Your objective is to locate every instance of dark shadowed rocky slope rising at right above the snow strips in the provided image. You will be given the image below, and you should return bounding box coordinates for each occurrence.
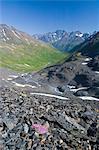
[31,32,99,98]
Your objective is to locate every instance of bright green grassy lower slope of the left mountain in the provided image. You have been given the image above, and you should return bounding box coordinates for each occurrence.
[0,45,68,72]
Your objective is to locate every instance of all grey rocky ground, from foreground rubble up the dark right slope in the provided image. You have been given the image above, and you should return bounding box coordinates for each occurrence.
[0,29,99,150]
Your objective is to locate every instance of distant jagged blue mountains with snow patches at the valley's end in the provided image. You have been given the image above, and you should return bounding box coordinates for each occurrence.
[33,30,89,51]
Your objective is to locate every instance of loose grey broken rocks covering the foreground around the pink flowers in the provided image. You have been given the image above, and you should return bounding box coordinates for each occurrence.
[0,87,99,150]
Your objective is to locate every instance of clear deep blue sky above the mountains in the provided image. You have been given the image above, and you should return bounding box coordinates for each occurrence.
[0,0,99,34]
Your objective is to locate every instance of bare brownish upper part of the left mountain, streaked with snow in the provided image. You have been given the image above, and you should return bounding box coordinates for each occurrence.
[0,24,37,44]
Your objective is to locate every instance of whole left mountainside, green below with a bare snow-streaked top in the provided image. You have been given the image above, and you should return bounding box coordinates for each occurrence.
[0,24,66,72]
